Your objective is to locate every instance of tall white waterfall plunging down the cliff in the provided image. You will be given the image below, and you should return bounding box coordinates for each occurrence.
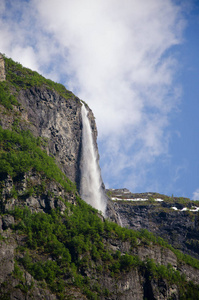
[80,104,106,215]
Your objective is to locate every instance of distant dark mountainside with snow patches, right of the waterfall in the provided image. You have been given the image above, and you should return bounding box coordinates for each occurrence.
[107,189,199,259]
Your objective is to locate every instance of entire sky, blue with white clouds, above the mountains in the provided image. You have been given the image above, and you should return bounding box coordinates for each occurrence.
[0,0,199,200]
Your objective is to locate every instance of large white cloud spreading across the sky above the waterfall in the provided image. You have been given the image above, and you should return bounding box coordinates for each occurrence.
[0,0,187,191]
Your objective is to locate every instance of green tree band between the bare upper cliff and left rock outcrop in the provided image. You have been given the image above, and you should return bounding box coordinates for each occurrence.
[0,126,75,191]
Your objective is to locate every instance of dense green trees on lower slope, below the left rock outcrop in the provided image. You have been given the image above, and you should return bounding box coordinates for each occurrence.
[11,204,109,299]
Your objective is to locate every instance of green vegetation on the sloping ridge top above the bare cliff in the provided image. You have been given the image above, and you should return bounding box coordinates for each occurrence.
[4,55,74,99]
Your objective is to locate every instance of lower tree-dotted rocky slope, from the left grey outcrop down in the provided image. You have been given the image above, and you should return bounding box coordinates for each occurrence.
[0,171,199,300]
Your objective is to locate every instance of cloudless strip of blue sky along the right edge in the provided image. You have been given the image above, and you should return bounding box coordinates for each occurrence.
[170,1,199,199]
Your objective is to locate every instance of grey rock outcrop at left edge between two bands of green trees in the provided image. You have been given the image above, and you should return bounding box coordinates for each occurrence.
[0,171,75,213]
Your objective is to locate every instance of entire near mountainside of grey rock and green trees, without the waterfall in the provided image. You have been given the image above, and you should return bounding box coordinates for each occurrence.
[0,57,199,300]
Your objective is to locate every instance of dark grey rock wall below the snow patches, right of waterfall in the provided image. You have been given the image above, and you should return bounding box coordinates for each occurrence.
[107,189,199,259]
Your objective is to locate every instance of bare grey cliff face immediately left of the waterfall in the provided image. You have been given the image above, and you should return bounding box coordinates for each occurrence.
[18,86,81,186]
